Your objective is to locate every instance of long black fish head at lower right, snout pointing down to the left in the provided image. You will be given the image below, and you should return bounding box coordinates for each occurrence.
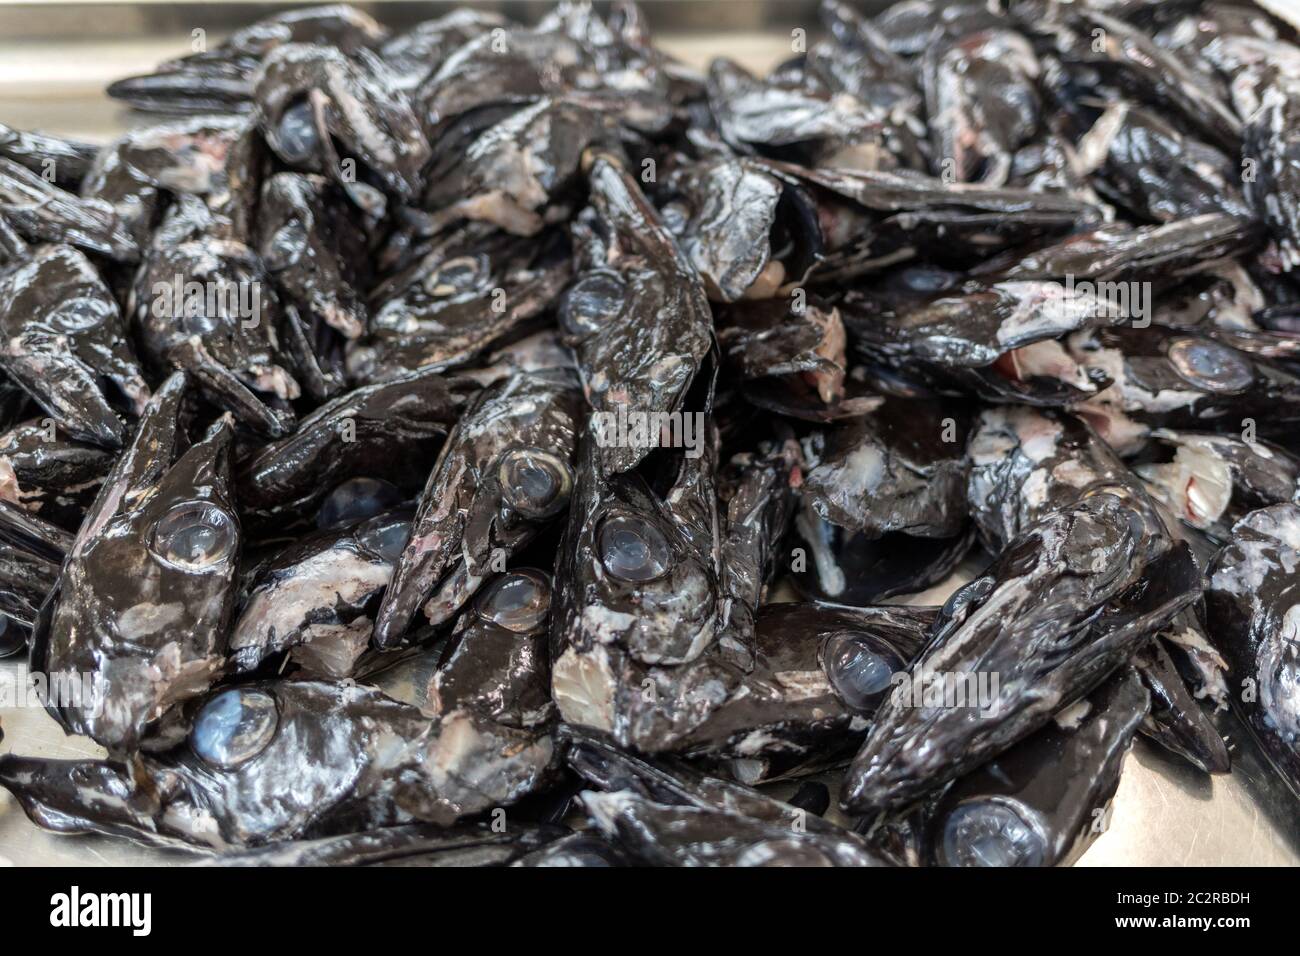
[841,493,1200,812]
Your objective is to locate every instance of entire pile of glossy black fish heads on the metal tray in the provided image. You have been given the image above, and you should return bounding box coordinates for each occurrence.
[0,0,1300,865]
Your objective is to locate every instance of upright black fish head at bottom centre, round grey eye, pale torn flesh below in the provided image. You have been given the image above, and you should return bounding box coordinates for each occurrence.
[551,434,733,752]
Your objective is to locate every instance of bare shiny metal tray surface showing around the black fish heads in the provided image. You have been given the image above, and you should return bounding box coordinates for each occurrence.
[0,0,1300,866]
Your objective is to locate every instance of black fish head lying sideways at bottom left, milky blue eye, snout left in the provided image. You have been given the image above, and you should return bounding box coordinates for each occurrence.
[0,682,554,851]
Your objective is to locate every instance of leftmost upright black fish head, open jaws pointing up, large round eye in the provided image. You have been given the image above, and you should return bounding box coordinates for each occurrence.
[31,373,239,754]
